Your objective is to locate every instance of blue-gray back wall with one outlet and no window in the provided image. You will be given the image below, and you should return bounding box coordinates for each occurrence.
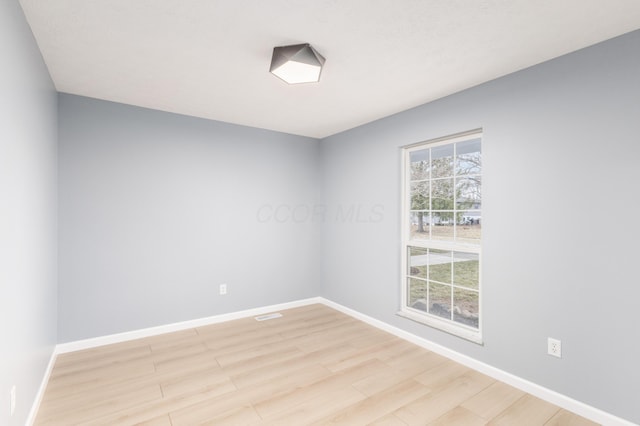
[58,94,320,343]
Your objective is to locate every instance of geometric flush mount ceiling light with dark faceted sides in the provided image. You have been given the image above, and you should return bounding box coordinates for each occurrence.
[269,43,324,84]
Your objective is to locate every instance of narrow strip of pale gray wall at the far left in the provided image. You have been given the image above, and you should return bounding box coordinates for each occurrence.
[0,1,57,425]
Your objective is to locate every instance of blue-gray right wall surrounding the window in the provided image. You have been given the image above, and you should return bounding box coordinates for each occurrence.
[321,31,640,423]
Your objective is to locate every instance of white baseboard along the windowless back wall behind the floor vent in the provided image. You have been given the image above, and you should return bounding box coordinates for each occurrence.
[55,297,322,354]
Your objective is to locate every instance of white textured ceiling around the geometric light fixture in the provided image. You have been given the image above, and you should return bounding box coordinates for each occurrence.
[21,0,640,138]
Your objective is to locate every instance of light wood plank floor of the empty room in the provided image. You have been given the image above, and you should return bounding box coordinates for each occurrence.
[35,305,594,426]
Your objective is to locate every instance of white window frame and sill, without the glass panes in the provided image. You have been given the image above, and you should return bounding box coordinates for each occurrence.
[398,129,483,344]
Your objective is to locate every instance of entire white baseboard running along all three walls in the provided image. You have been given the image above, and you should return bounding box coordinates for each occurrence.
[41,297,637,426]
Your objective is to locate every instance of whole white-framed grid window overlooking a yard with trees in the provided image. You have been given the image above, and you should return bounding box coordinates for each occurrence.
[399,131,482,343]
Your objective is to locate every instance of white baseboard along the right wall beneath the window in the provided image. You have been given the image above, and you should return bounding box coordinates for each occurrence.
[320,298,637,426]
